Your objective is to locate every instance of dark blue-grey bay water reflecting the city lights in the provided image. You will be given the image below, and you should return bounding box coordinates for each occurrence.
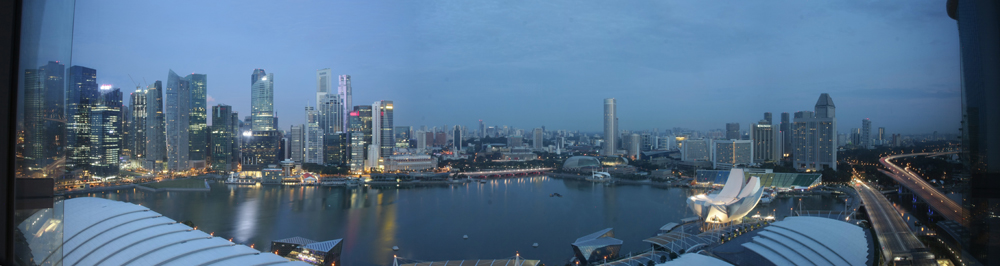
[66,177,843,265]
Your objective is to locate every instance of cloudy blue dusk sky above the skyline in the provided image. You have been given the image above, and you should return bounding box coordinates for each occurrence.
[72,0,961,134]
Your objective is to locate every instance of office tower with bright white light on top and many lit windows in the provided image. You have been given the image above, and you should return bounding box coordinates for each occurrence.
[90,85,122,178]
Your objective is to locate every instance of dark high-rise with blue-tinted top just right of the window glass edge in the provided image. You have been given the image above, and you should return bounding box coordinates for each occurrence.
[66,66,100,169]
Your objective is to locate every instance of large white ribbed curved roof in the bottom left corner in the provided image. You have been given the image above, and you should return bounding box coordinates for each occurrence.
[30,198,309,266]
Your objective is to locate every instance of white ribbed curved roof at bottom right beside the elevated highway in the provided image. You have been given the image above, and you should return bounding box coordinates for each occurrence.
[743,216,868,265]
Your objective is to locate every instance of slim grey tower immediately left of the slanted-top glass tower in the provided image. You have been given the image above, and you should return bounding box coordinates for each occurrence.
[143,80,167,172]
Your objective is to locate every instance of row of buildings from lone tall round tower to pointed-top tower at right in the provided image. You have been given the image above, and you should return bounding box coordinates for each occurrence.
[601,93,840,171]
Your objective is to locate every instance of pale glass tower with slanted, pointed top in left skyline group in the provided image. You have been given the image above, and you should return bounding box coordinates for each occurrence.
[164,70,191,171]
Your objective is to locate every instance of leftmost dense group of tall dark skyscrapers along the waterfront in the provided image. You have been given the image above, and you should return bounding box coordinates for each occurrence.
[22,62,217,178]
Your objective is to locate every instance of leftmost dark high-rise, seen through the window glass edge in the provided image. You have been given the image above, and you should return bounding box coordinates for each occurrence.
[24,61,65,177]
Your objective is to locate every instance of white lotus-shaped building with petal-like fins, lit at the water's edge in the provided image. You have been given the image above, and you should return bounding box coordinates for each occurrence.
[687,169,764,223]
